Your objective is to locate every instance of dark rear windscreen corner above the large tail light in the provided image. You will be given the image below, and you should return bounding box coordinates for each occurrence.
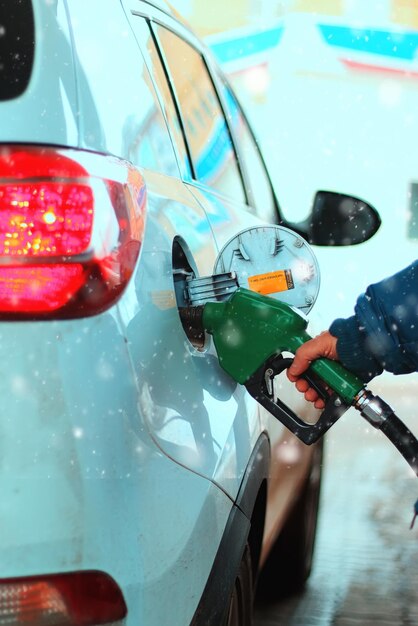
[0,0,35,100]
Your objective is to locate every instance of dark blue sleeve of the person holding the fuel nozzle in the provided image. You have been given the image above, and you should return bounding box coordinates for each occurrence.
[330,261,418,381]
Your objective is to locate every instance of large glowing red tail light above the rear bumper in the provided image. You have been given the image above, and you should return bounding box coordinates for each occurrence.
[0,146,145,319]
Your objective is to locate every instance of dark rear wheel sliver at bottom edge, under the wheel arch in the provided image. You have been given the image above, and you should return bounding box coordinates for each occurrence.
[224,544,254,626]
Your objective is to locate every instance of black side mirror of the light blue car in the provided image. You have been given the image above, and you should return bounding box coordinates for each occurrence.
[305,191,381,246]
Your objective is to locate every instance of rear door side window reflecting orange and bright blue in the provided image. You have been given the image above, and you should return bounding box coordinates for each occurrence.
[156,26,246,202]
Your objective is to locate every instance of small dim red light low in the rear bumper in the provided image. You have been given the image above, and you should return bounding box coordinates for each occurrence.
[0,572,127,626]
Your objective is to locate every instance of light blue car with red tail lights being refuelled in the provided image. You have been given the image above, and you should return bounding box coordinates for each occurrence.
[0,0,378,626]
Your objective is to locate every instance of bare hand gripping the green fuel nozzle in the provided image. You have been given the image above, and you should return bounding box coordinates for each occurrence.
[287,330,338,409]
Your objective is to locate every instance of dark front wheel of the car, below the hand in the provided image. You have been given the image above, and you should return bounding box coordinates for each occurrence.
[258,441,323,601]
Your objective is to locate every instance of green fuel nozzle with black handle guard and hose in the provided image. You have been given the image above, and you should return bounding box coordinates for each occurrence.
[181,288,418,482]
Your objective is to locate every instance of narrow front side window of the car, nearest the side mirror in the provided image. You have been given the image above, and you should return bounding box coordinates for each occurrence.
[221,78,278,223]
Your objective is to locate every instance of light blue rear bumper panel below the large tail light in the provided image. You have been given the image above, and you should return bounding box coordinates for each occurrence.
[0,310,232,626]
